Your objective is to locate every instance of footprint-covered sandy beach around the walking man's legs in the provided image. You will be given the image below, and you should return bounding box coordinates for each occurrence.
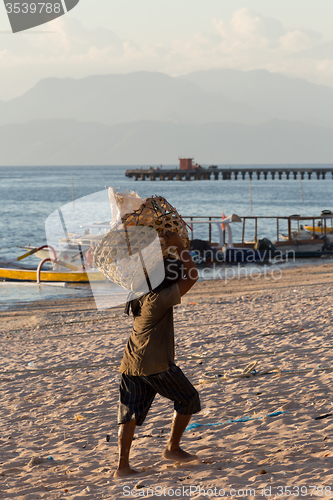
[0,261,333,500]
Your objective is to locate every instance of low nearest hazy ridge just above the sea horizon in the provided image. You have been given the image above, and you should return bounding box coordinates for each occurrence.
[0,120,333,165]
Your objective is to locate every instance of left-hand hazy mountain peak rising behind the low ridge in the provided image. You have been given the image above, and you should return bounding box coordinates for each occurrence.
[0,72,272,125]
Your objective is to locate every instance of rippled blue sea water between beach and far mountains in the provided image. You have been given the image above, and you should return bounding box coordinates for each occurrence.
[0,165,333,307]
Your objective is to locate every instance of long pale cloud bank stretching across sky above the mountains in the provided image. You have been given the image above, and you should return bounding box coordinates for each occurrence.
[0,8,333,98]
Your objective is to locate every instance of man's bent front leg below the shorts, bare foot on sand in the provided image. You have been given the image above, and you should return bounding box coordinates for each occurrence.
[163,411,198,462]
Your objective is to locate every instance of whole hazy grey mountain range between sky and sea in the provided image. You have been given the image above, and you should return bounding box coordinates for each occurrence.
[0,69,333,166]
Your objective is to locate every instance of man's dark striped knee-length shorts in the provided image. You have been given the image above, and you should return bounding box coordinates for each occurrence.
[118,364,201,425]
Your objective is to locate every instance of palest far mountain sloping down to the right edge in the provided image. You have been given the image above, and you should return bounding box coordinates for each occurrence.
[180,69,333,126]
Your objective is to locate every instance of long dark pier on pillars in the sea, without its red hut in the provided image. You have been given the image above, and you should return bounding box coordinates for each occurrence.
[125,165,333,181]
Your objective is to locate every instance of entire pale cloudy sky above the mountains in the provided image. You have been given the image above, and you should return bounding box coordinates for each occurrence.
[0,0,333,100]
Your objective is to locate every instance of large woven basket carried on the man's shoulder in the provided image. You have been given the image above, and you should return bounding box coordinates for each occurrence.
[94,196,190,291]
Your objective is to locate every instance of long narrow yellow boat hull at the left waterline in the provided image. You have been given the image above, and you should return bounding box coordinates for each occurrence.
[0,268,105,283]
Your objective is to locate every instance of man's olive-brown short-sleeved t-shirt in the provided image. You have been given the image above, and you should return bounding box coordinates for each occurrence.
[119,284,181,376]
